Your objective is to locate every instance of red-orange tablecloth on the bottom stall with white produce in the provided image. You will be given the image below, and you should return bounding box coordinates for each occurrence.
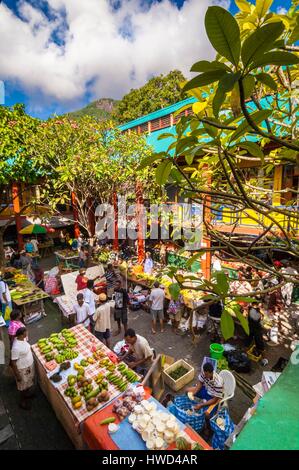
[83,391,211,450]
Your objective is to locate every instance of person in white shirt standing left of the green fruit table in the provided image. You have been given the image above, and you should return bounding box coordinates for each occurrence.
[11,327,35,410]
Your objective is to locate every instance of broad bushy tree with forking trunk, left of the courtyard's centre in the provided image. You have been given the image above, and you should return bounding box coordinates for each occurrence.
[31,116,163,237]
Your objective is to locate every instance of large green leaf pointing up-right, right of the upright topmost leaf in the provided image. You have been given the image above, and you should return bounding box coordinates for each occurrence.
[241,22,284,68]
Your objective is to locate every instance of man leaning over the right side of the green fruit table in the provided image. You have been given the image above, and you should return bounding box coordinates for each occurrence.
[121,328,153,375]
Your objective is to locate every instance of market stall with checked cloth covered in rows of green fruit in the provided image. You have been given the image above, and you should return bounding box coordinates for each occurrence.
[32,325,139,449]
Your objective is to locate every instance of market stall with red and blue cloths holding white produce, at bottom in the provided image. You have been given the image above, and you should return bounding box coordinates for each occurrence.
[83,387,211,450]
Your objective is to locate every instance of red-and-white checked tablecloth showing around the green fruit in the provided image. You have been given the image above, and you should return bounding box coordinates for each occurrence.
[32,325,132,449]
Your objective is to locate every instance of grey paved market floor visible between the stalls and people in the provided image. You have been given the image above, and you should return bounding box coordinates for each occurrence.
[0,300,287,450]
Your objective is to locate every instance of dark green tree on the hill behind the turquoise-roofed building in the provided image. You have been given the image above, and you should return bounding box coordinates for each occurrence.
[112,70,185,124]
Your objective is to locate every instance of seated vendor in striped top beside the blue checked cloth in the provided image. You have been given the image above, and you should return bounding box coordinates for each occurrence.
[187,362,223,417]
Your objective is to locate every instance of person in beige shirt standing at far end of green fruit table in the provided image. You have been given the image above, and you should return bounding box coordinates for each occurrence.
[93,293,114,348]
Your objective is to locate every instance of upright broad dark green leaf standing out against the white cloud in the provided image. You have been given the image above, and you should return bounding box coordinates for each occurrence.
[205,6,241,65]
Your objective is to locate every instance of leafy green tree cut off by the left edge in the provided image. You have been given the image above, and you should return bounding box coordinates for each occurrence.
[0,104,39,265]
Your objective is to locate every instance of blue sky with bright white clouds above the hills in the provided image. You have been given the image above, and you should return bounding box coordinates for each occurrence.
[0,0,290,119]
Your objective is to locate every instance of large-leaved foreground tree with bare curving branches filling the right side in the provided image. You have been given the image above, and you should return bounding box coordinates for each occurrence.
[142,0,299,339]
